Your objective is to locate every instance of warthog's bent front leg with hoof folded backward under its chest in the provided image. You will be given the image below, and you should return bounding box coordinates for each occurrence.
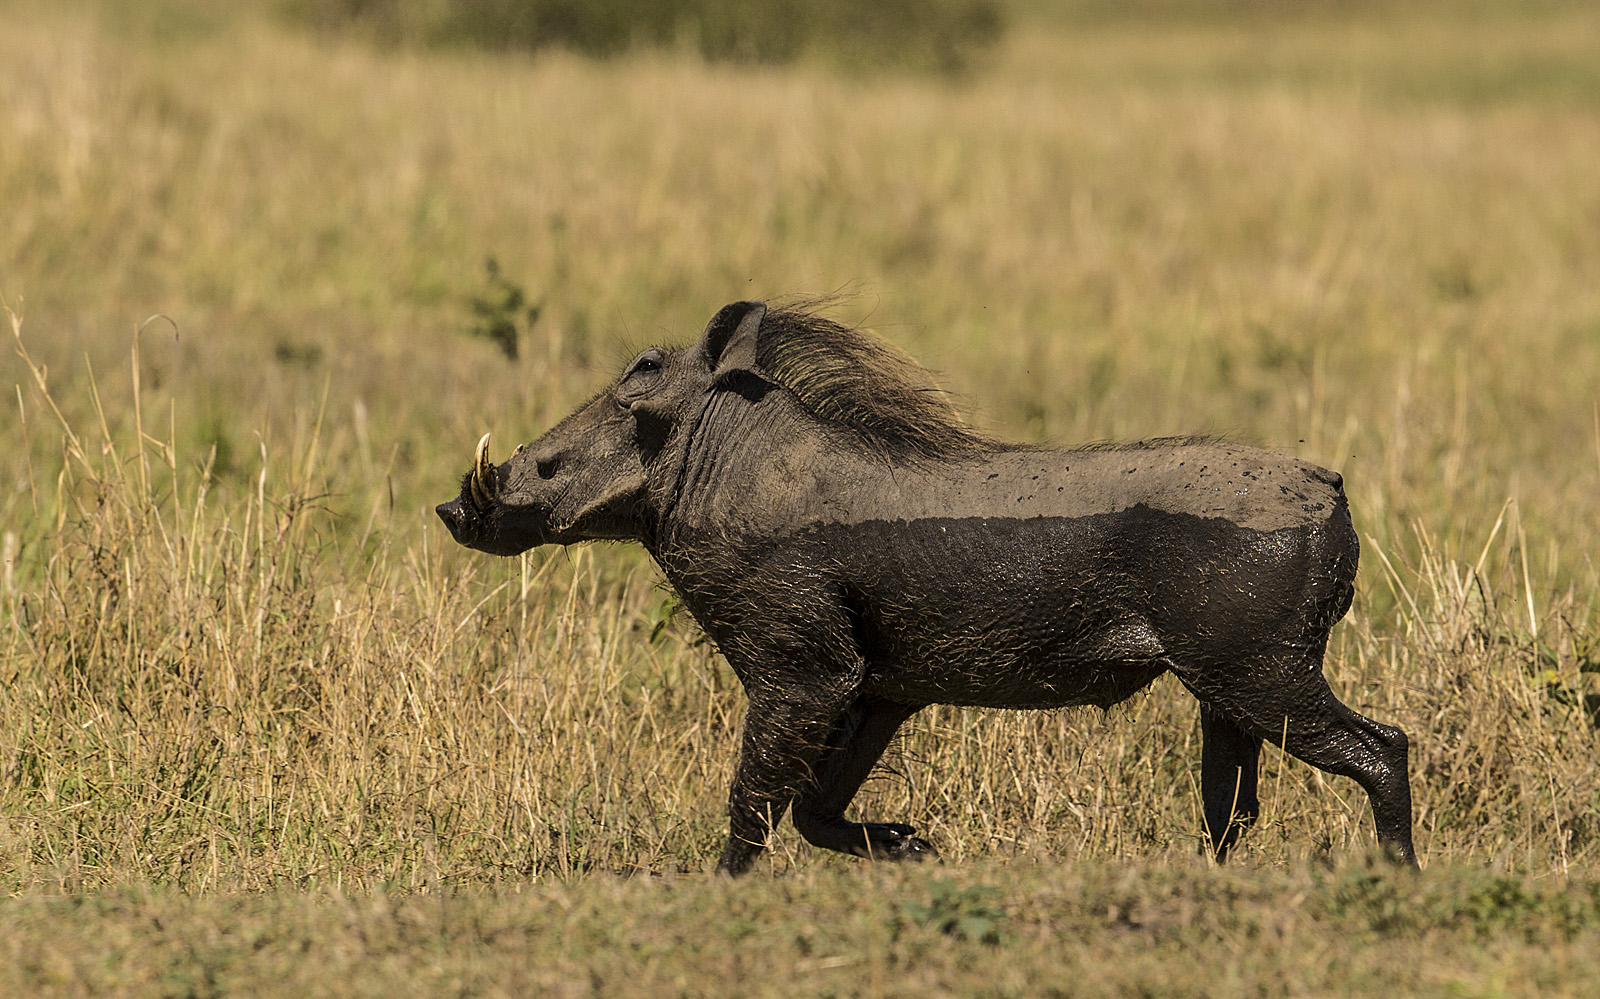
[794,696,934,860]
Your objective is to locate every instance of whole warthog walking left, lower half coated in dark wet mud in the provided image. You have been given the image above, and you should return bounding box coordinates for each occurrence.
[438,303,1416,874]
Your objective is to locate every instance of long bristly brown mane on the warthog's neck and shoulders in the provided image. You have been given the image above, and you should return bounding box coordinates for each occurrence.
[755,303,1018,461]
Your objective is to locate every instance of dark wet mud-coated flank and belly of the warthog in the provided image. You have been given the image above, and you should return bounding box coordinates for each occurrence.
[787,506,1349,708]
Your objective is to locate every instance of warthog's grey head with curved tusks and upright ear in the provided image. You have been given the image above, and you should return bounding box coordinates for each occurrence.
[437,303,766,556]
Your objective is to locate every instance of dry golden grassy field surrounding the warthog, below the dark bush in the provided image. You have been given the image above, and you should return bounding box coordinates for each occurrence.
[0,0,1600,996]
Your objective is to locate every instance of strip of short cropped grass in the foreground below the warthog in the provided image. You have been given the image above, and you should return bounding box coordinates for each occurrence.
[0,863,1600,997]
